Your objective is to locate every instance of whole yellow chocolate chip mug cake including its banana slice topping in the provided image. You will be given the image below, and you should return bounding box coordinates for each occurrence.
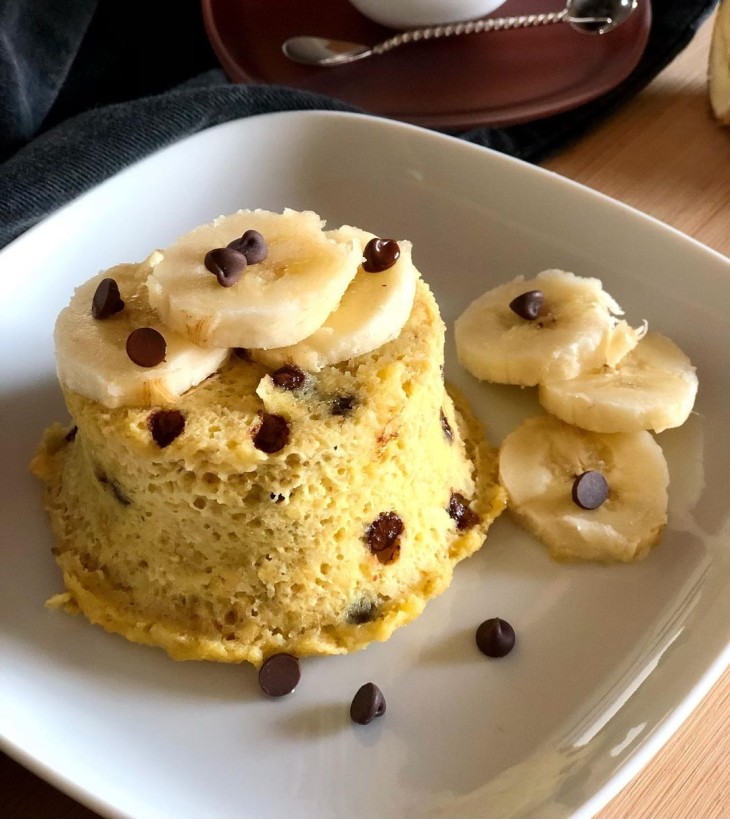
[32,210,505,665]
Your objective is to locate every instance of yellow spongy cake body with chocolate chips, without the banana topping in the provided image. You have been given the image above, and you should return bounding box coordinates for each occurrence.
[33,282,504,665]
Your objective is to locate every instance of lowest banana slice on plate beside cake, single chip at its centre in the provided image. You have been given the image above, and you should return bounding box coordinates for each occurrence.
[499,415,669,563]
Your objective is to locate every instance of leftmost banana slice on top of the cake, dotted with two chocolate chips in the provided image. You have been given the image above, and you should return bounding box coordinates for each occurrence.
[54,254,229,408]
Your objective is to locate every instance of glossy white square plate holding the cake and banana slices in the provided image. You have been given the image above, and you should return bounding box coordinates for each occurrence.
[0,112,730,819]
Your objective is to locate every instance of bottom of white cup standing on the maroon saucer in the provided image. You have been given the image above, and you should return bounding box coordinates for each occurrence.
[350,0,505,29]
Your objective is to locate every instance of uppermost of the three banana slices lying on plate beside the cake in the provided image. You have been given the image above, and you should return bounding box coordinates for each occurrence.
[454,270,644,387]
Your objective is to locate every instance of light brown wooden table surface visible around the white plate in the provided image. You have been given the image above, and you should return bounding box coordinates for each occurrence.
[0,8,730,819]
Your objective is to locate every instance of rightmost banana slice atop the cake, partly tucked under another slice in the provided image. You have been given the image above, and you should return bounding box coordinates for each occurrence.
[251,226,419,372]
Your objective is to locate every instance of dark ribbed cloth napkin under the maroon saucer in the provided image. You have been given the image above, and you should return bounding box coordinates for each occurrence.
[0,0,717,247]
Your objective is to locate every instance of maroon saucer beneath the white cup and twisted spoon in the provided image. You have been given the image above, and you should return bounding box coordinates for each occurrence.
[202,0,651,128]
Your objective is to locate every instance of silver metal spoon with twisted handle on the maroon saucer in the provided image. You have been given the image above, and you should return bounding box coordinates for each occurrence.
[281,0,638,67]
